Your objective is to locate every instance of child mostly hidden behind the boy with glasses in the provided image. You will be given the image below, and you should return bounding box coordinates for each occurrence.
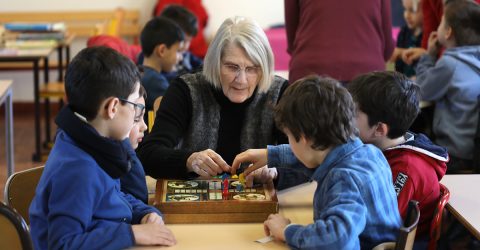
[120,85,148,204]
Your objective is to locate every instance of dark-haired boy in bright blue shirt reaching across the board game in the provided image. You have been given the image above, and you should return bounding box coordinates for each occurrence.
[232,76,401,249]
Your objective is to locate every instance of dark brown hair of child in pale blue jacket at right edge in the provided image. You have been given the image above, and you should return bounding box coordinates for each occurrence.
[444,0,480,46]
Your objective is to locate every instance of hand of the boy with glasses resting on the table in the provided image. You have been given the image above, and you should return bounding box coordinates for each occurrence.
[132,224,177,246]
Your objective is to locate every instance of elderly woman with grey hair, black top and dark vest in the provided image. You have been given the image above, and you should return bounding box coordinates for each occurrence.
[137,17,287,178]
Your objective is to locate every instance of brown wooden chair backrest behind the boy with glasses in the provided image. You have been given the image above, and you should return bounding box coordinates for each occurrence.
[4,166,44,224]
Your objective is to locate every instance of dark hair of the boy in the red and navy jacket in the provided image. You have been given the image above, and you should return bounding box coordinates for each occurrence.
[347,71,420,139]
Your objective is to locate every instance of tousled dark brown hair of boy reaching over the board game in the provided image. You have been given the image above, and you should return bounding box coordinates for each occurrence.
[275,75,357,150]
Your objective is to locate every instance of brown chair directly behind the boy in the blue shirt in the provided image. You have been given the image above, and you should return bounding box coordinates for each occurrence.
[373,200,420,250]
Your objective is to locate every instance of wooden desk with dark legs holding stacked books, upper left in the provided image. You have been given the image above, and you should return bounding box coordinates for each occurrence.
[0,47,55,161]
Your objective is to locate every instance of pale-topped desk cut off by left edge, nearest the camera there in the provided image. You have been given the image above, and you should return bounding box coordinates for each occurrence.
[0,80,15,178]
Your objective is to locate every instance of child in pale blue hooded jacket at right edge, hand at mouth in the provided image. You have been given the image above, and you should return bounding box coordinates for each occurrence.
[416,0,480,174]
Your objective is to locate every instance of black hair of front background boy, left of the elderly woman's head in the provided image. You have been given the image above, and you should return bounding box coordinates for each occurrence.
[140,17,184,56]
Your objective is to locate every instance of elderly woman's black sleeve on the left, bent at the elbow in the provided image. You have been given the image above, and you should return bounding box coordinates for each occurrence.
[137,79,193,178]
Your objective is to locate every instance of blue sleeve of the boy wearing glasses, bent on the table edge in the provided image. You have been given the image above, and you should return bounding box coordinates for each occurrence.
[47,162,135,249]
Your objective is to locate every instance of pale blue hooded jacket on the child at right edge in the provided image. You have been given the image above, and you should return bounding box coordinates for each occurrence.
[417,46,480,159]
